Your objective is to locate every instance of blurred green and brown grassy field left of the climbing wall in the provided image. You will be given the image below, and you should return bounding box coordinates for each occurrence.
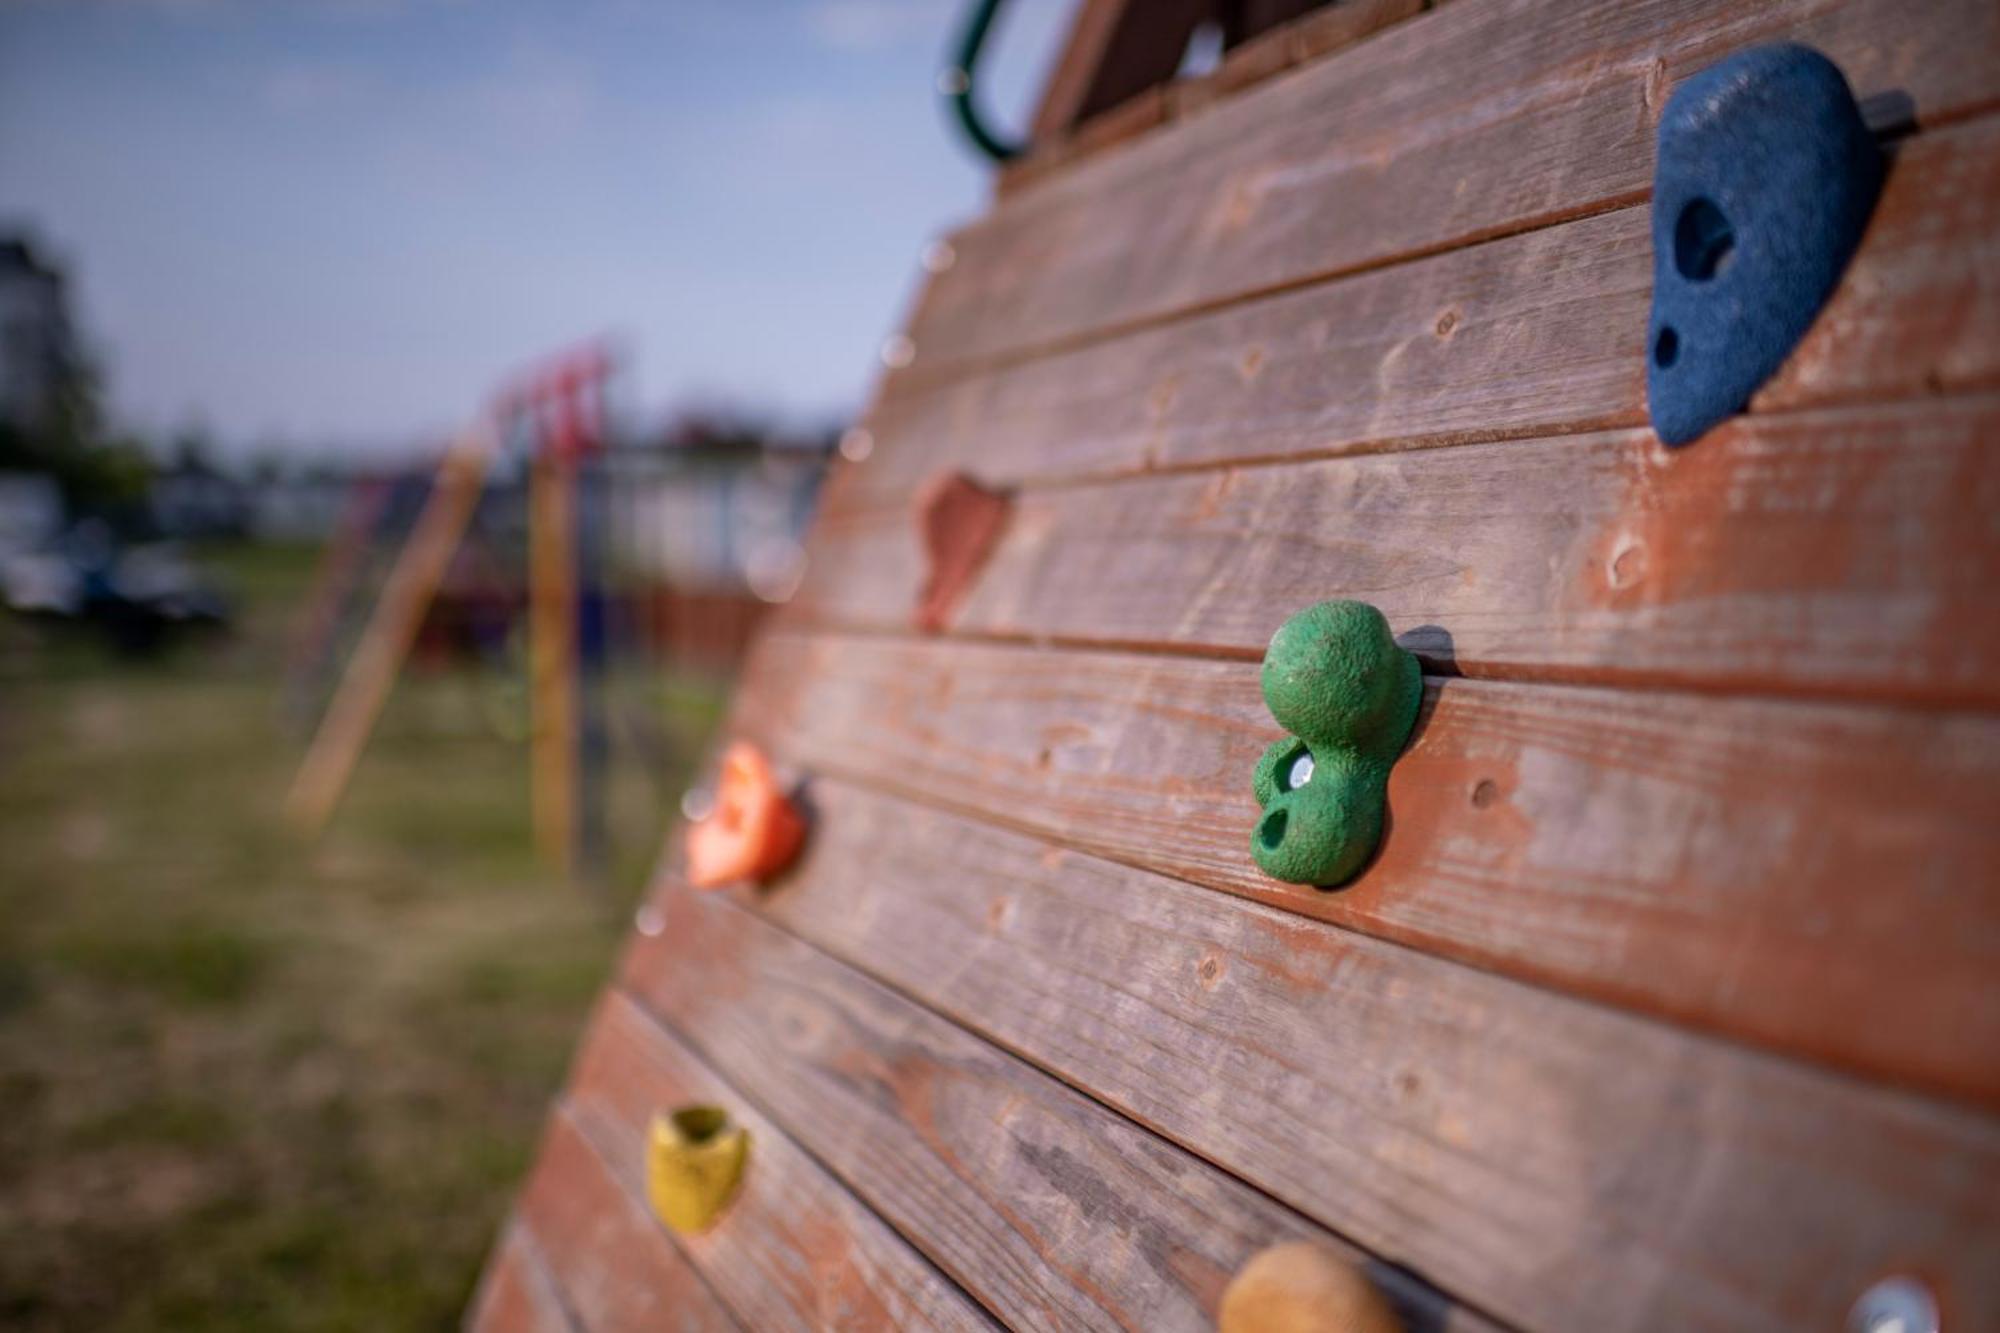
[0,550,716,1331]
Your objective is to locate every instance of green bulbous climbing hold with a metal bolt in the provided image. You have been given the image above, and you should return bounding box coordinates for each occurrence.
[1250,602,1424,889]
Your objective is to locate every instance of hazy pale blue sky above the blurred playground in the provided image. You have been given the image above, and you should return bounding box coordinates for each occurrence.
[0,0,1070,452]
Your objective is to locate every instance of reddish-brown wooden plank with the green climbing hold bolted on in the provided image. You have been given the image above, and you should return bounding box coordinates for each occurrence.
[736,634,2000,1107]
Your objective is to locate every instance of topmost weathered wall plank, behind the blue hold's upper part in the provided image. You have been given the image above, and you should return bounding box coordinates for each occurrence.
[898,0,2000,382]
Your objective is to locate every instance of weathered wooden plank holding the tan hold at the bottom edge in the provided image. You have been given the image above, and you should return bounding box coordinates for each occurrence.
[622,891,1486,1333]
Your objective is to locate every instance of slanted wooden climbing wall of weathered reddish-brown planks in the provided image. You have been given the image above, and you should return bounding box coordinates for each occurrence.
[470,0,2000,1333]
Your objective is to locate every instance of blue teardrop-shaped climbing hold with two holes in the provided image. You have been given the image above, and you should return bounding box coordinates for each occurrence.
[1646,42,1882,444]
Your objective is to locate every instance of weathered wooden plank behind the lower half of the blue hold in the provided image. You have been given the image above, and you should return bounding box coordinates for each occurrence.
[846,118,2000,504]
